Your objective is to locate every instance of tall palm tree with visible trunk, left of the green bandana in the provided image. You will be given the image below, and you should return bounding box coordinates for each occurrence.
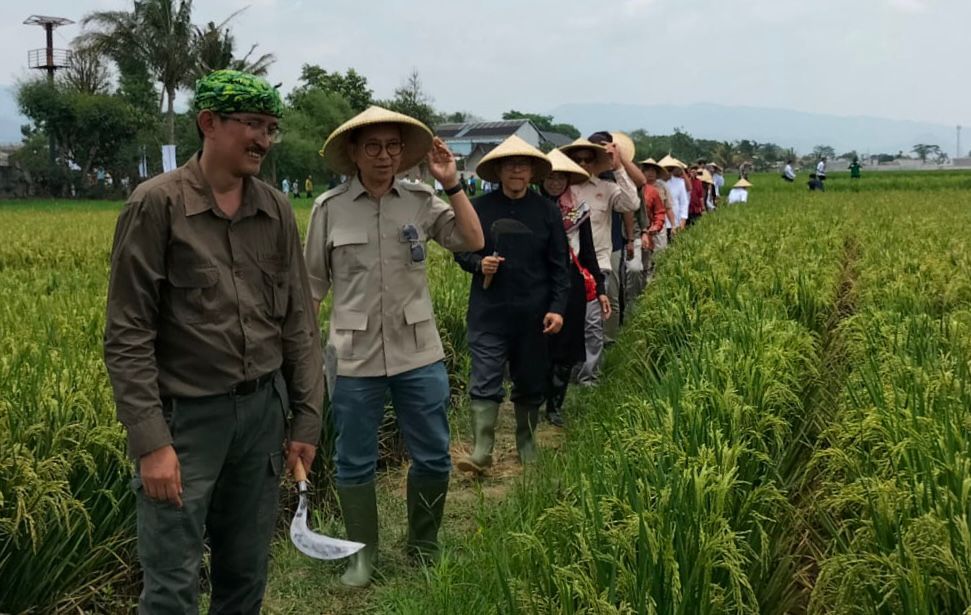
[79,0,197,143]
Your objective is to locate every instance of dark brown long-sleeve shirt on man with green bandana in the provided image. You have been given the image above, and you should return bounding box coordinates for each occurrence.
[105,156,324,459]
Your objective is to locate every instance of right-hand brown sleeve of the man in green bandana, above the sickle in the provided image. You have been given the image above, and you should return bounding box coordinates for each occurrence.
[282,212,325,444]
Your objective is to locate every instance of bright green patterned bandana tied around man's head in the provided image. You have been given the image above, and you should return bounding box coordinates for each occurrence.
[192,70,283,117]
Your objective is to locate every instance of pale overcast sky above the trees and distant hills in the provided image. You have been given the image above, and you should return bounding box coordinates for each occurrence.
[0,0,971,125]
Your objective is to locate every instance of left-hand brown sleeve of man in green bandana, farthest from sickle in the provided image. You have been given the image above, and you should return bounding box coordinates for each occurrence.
[104,197,172,459]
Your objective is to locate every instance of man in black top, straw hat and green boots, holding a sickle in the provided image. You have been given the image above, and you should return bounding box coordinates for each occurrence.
[455,135,570,474]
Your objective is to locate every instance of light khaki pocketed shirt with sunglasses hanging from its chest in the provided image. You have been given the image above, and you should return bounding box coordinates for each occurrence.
[305,176,469,377]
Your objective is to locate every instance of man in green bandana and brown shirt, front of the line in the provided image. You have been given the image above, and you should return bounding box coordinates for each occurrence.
[105,70,324,614]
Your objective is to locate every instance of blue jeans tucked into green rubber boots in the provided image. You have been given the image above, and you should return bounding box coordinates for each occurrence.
[331,361,452,487]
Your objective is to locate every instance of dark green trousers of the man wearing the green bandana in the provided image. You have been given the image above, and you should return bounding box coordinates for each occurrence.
[133,377,286,615]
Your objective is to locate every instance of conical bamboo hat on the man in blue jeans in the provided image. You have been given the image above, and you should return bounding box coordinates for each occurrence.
[320,105,433,175]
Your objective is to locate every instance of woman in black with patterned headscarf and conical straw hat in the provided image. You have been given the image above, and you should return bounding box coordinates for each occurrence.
[542,150,610,427]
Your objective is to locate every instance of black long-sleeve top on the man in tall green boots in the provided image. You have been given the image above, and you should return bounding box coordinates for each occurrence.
[455,189,570,330]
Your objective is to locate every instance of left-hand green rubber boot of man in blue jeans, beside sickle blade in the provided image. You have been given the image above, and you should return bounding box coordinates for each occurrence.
[337,481,378,587]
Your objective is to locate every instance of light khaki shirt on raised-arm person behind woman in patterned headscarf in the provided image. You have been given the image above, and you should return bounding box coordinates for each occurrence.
[570,168,641,272]
